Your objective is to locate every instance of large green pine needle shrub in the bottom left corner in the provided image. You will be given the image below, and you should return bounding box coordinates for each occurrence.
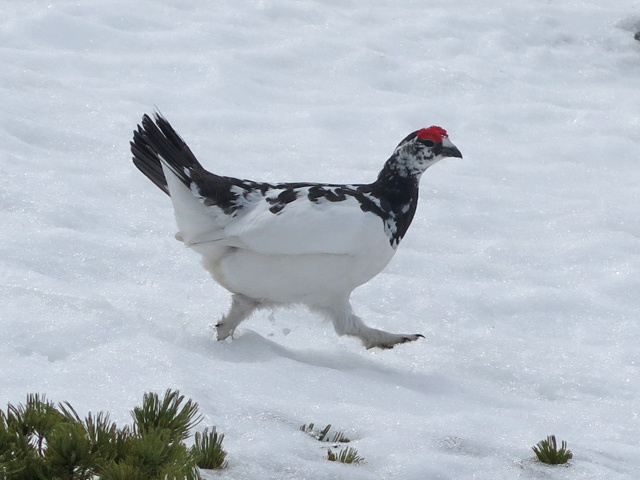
[0,390,226,480]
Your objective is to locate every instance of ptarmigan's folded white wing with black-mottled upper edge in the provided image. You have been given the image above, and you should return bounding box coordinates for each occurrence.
[161,159,392,255]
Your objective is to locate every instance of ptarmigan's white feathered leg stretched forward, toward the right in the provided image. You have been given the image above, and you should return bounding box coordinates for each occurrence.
[314,301,424,349]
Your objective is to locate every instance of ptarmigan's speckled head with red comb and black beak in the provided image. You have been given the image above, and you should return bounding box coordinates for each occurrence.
[389,125,462,178]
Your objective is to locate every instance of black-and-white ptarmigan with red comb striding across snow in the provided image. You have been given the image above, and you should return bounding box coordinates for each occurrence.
[131,114,462,348]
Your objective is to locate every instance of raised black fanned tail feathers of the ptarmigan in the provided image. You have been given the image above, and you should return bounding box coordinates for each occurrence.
[131,113,202,195]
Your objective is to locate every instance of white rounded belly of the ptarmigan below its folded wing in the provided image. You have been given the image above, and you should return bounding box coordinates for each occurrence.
[198,248,395,306]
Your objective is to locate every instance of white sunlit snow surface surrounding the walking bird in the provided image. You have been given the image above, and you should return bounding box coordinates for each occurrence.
[0,0,640,480]
